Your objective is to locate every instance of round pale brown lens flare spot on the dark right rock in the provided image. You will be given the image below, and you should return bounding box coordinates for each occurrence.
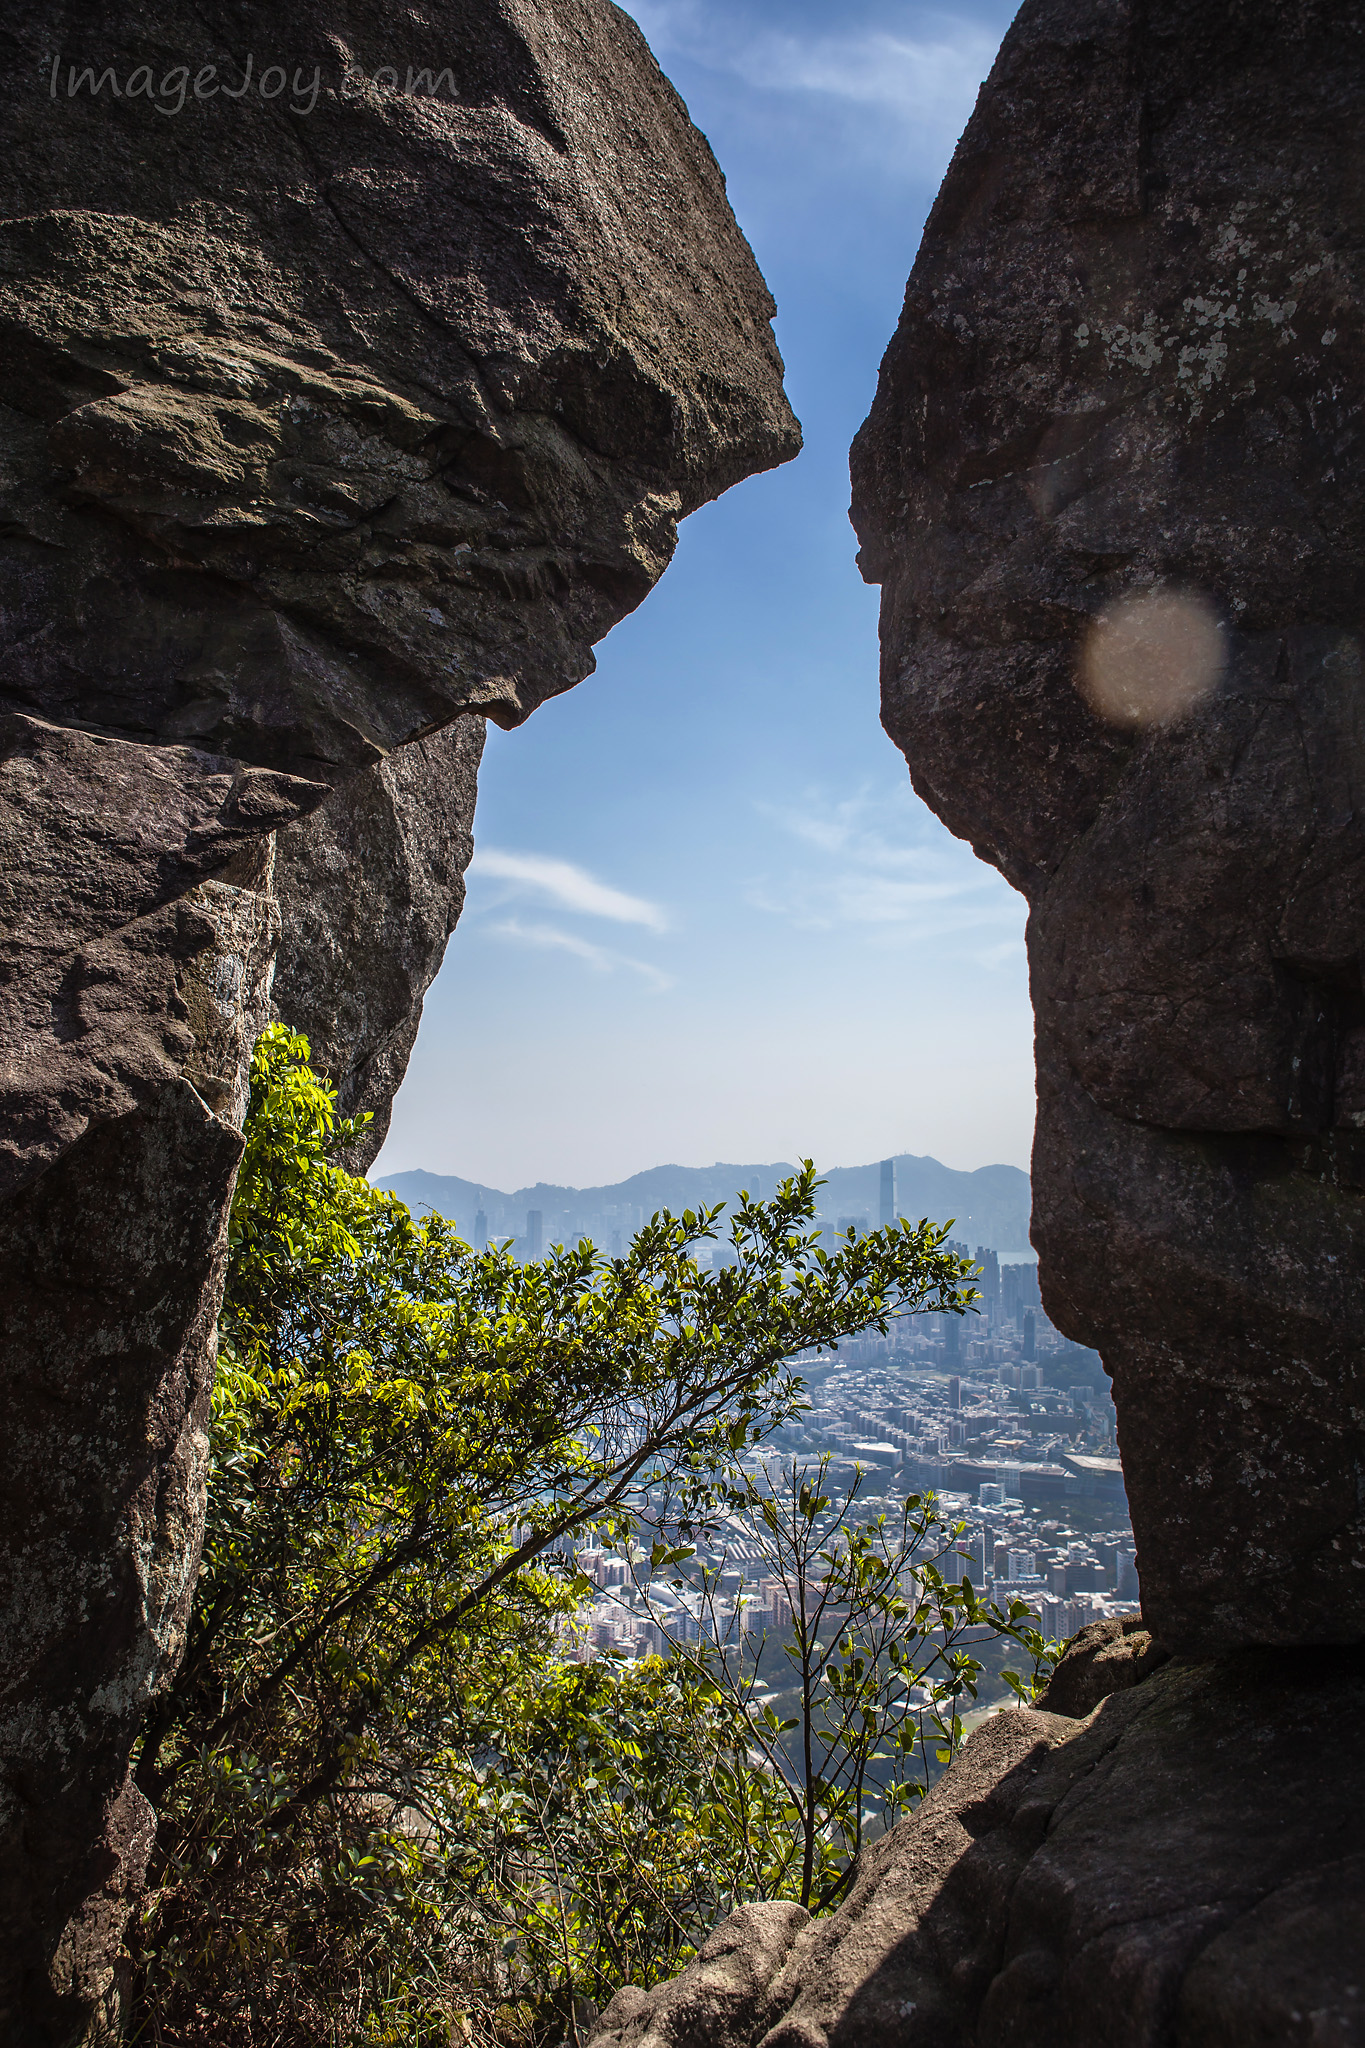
[1076,590,1226,727]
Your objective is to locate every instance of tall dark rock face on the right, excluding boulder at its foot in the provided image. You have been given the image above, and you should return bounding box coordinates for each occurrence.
[853,0,1365,1653]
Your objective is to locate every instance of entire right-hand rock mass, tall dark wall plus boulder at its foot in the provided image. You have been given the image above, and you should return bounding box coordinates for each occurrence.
[613,0,1365,2048]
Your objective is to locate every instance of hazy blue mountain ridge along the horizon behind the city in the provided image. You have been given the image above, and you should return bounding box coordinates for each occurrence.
[377,1153,1031,1257]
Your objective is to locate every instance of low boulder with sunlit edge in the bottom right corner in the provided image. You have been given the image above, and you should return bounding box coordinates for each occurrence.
[593,1651,1365,2048]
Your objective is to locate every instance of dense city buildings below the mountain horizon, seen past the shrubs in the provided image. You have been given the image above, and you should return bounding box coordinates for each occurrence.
[581,1247,1140,1687]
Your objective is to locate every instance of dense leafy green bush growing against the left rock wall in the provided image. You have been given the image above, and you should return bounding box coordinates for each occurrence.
[137,1026,998,2048]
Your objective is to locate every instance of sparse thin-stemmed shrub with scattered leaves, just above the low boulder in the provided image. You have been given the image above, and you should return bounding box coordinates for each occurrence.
[613,1458,1058,1913]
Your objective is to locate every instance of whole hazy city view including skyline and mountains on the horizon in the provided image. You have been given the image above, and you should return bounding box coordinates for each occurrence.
[391,1155,1140,1659]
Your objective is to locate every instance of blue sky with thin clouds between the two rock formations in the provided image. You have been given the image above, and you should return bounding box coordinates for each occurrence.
[375,0,1033,1188]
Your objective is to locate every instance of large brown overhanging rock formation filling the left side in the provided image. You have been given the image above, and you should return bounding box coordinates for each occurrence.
[0,0,796,2044]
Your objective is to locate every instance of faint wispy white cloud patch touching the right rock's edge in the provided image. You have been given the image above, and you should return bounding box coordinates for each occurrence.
[747,791,1023,946]
